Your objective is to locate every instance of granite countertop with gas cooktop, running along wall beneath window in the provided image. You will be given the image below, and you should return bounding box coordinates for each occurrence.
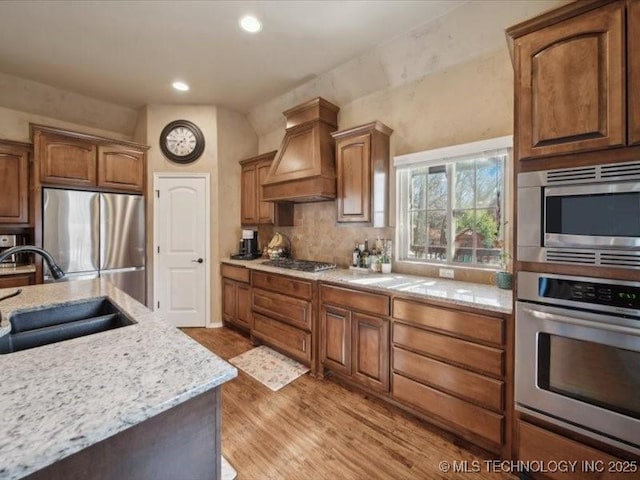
[222,259,513,314]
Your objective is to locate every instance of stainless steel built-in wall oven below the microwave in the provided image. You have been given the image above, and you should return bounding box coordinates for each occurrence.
[515,272,640,454]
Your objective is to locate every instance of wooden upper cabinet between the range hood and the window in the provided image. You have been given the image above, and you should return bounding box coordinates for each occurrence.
[331,122,393,227]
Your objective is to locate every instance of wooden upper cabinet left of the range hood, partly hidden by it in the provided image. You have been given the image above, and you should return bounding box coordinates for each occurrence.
[240,151,293,226]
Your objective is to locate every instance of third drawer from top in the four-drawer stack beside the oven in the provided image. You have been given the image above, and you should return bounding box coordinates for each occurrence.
[393,347,504,411]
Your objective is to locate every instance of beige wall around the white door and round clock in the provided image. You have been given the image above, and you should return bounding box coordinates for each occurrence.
[141,105,258,326]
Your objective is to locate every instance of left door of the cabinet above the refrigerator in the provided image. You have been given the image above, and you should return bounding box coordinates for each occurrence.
[36,135,96,187]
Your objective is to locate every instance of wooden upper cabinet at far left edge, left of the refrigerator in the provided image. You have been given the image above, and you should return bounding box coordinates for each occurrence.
[0,140,31,225]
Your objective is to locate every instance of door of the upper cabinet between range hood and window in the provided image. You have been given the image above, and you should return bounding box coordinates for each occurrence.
[336,134,371,222]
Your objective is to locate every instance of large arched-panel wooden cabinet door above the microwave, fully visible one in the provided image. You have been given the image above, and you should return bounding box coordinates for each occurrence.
[516,2,626,158]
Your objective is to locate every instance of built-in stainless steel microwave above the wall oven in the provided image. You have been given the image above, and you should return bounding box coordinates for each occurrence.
[517,162,640,268]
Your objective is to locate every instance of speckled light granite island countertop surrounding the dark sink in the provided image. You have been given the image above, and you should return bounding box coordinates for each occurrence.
[0,280,237,479]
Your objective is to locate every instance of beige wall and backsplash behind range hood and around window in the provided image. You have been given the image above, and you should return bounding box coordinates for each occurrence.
[259,48,513,281]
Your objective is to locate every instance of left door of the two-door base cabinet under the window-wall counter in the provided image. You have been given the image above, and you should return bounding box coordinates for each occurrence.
[320,306,351,375]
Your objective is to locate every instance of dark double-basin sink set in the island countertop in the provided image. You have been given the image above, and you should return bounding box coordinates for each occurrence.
[0,297,136,354]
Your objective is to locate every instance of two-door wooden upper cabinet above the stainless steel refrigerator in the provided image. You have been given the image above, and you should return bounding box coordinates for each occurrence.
[33,125,148,193]
